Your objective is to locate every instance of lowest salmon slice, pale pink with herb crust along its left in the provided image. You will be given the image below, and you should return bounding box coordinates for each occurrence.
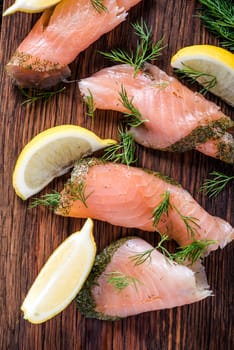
[76,237,212,320]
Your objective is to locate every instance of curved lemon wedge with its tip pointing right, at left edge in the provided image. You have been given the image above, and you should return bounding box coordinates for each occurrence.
[13,125,116,199]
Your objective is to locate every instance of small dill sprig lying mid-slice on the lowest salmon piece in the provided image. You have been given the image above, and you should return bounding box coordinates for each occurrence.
[105,271,141,290]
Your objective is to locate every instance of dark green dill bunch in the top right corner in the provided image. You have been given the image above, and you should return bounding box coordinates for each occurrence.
[199,0,234,51]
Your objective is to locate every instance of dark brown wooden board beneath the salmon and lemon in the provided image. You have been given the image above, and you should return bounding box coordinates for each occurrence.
[0,0,234,350]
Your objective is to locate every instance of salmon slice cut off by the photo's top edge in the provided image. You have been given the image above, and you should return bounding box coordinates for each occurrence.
[6,0,141,89]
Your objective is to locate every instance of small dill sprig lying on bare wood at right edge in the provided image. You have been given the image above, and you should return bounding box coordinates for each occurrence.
[200,171,234,197]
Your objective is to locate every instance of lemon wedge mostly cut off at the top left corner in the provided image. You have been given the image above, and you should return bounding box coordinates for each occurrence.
[3,0,61,16]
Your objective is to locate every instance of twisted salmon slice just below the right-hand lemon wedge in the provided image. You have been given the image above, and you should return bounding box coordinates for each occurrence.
[79,63,234,164]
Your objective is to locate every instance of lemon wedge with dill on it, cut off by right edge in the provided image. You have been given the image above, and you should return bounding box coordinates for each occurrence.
[171,45,234,106]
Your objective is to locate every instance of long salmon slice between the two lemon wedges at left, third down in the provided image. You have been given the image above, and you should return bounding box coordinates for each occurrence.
[55,158,234,251]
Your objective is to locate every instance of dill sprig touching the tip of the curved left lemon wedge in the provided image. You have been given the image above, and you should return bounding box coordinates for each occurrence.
[102,126,136,166]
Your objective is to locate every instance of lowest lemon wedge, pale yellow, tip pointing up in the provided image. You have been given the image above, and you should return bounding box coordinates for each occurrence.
[21,219,96,323]
